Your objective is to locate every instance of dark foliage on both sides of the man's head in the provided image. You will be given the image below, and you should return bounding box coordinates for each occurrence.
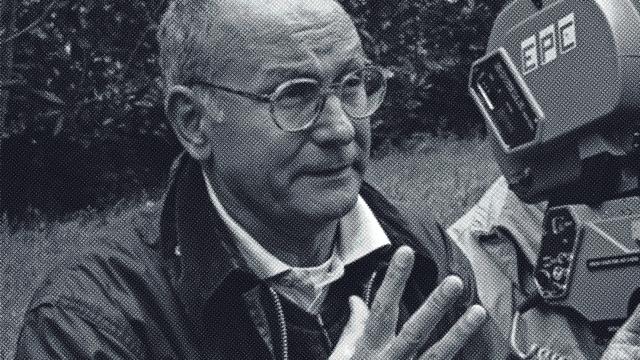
[0,0,506,222]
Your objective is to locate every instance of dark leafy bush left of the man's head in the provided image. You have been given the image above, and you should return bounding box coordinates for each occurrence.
[0,0,179,217]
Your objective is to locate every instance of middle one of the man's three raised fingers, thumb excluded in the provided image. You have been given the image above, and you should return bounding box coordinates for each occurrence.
[390,276,464,359]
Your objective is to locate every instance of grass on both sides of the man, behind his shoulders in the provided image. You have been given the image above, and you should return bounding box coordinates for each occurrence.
[0,137,498,359]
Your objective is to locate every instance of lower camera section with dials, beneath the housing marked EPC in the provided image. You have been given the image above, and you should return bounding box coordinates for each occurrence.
[534,197,640,338]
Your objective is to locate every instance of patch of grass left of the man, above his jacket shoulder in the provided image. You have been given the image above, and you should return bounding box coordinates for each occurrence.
[0,197,164,360]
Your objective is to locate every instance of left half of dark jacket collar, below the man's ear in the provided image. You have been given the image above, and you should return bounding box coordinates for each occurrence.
[160,154,257,318]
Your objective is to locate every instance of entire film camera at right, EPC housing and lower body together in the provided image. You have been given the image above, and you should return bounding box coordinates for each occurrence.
[469,0,640,338]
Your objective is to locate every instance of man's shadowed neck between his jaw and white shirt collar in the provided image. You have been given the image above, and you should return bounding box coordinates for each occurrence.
[207,169,339,267]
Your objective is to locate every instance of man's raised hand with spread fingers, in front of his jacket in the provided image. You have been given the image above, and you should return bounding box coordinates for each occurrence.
[329,247,487,360]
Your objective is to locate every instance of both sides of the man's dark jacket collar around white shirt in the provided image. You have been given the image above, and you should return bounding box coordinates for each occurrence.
[160,153,440,322]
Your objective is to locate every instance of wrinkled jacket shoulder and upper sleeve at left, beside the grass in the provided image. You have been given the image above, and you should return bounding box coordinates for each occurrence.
[17,204,167,358]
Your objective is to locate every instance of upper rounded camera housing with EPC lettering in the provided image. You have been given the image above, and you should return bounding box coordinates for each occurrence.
[469,0,640,204]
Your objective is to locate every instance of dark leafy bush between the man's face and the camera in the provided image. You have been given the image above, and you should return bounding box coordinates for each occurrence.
[342,0,505,143]
